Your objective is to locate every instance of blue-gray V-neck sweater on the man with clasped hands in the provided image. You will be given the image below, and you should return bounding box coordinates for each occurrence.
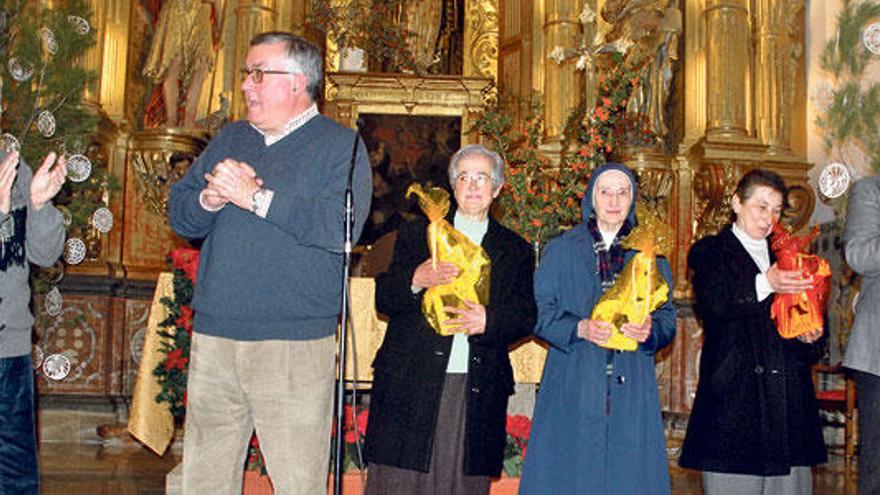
[168,115,372,340]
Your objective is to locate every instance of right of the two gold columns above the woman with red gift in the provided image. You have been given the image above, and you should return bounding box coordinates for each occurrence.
[755,0,804,153]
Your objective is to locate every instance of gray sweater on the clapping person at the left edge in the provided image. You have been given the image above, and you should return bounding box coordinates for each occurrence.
[0,151,64,358]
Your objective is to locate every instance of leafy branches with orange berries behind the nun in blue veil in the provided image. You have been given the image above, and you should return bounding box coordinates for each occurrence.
[473,54,654,244]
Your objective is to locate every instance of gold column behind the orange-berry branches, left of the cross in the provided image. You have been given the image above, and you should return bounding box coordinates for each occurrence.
[542,0,584,142]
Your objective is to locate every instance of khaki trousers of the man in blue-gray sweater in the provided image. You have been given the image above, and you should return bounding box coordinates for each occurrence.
[183,333,336,495]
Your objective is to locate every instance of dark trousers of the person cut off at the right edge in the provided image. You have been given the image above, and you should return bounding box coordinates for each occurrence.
[854,371,880,495]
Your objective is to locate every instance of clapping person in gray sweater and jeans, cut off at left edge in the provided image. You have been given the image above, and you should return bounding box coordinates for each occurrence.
[0,151,67,495]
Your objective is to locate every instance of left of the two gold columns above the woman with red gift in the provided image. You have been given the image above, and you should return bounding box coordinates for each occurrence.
[705,0,751,139]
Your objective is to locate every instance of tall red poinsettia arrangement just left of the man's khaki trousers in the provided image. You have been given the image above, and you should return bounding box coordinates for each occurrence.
[153,248,199,422]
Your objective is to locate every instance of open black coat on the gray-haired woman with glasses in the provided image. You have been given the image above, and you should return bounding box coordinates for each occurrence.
[365,215,537,476]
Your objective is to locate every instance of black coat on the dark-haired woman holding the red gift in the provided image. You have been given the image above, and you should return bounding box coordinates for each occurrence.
[679,226,826,476]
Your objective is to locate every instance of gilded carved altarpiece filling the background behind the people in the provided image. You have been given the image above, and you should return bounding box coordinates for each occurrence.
[32,0,814,426]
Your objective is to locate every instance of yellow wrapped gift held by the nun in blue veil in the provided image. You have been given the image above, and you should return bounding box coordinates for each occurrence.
[590,205,674,351]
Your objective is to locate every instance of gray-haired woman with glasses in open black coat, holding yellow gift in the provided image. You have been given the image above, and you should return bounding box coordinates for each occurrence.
[366,145,536,494]
